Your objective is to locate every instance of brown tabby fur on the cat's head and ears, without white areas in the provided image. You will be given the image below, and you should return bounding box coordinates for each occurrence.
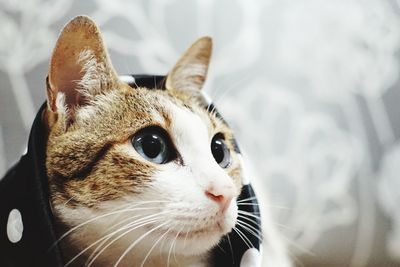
[43,17,241,266]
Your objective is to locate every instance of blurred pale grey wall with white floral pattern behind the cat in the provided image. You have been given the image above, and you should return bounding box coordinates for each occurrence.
[0,0,400,267]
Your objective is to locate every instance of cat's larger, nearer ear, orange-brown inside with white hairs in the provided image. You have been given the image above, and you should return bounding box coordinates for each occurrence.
[47,16,118,115]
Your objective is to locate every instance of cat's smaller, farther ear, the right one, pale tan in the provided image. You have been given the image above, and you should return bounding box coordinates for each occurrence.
[165,37,212,90]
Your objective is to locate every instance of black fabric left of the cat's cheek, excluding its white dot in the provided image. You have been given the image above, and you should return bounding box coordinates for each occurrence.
[0,104,62,267]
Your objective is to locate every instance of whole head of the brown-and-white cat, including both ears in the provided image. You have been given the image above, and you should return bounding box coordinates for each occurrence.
[44,17,241,262]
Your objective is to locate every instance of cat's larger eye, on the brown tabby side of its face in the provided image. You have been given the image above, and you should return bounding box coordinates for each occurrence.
[132,127,172,164]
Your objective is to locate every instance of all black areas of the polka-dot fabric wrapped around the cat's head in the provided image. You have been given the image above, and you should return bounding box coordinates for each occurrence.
[0,75,261,267]
